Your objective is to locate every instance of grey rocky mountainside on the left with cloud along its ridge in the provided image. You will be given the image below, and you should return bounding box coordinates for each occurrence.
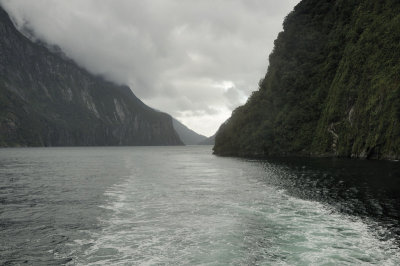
[0,8,182,146]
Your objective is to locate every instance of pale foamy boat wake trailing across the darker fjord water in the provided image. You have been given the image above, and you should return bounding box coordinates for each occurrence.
[70,155,400,265]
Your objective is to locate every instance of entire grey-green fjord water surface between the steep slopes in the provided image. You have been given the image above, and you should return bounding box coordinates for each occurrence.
[0,146,400,265]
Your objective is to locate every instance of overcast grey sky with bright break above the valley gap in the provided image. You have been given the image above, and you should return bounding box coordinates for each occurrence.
[0,0,299,136]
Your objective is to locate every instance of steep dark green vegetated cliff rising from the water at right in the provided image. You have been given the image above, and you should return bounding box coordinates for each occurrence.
[214,0,400,159]
